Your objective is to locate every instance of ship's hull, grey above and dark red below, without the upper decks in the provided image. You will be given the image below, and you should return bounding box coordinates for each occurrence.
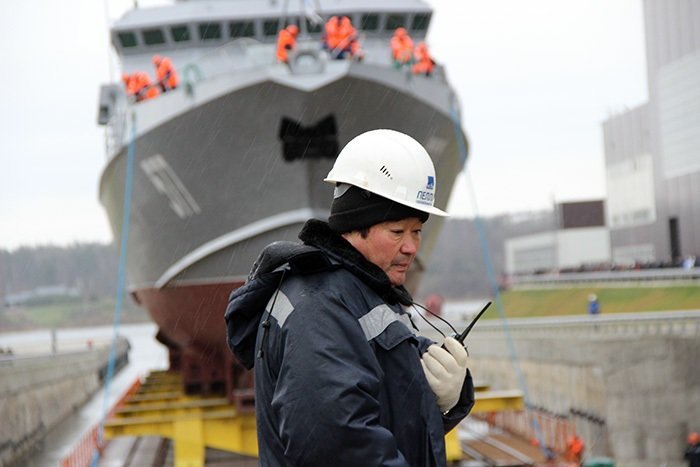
[100,64,466,362]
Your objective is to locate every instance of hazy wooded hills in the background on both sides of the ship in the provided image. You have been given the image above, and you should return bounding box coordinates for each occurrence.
[0,211,554,303]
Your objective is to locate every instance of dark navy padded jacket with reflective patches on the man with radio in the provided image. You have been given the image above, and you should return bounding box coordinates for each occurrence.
[226,220,474,467]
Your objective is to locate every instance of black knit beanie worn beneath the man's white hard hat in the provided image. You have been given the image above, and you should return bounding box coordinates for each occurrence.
[328,185,429,233]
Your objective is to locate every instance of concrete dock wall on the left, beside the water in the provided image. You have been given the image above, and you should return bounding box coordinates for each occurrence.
[0,339,129,466]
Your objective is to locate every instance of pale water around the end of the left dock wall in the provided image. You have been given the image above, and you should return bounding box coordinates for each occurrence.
[0,323,168,467]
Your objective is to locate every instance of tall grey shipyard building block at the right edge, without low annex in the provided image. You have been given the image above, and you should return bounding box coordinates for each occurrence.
[603,0,700,265]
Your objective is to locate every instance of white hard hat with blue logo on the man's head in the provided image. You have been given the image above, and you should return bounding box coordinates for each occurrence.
[324,130,448,217]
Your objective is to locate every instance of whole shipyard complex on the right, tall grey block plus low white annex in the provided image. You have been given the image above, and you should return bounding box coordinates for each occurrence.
[505,0,700,274]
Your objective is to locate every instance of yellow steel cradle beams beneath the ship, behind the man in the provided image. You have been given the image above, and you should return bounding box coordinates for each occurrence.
[104,372,524,467]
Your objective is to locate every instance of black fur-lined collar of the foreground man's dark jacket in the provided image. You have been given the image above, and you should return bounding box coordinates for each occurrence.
[299,219,413,306]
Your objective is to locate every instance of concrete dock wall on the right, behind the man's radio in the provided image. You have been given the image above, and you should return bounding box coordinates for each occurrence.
[454,312,700,467]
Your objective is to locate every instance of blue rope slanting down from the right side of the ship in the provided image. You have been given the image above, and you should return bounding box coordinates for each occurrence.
[450,106,550,457]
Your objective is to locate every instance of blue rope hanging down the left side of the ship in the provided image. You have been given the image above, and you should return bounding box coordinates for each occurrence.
[91,114,136,467]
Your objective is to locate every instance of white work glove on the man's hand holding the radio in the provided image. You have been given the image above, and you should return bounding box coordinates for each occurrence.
[421,337,467,413]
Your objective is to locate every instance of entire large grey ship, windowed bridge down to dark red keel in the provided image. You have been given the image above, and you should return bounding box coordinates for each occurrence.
[98,0,467,404]
